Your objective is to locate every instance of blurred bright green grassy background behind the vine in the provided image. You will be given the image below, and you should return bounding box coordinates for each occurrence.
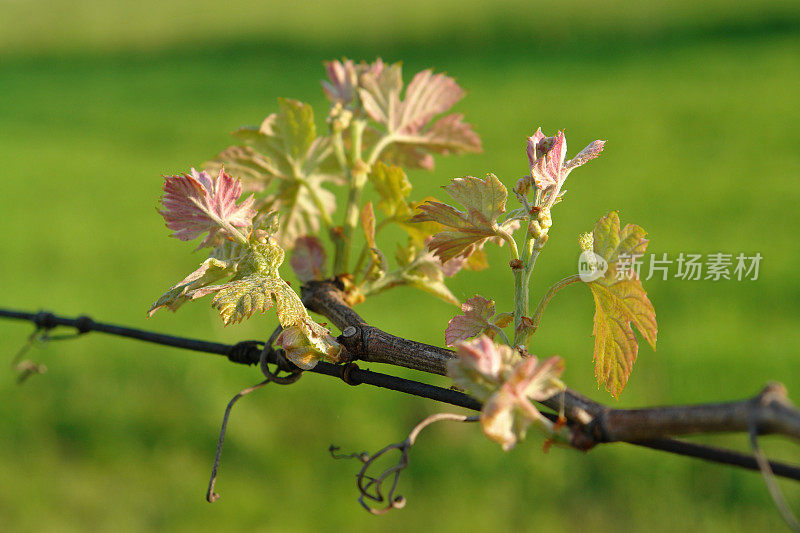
[0,0,800,531]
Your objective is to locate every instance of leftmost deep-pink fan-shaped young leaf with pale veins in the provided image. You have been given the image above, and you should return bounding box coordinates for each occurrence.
[160,169,256,248]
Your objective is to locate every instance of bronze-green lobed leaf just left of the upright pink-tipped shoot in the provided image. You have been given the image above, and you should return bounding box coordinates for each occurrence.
[410,174,516,263]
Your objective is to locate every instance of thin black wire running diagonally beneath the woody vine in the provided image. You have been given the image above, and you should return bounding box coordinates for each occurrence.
[0,309,800,481]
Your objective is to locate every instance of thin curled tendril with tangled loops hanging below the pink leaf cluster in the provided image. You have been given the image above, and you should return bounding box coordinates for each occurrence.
[328,413,478,515]
